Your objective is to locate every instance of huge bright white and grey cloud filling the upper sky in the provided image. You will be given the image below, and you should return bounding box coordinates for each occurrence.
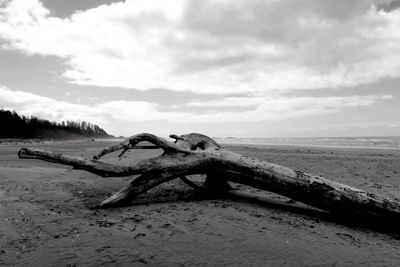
[0,0,400,95]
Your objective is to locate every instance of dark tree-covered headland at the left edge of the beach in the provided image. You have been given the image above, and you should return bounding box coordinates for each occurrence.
[0,109,111,139]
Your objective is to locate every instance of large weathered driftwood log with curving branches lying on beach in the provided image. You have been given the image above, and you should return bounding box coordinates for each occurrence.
[18,133,400,222]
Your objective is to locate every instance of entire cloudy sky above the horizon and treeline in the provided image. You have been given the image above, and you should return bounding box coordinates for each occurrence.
[0,0,400,137]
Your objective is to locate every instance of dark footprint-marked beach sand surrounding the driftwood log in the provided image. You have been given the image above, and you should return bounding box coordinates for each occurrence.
[0,141,400,266]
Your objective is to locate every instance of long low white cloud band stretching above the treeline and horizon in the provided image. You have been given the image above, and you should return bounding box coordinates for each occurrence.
[0,86,392,128]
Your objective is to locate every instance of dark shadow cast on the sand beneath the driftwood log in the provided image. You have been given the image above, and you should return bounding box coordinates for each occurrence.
[84,185,400,240]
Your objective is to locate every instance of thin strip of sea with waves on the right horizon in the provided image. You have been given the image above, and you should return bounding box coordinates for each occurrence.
[215,136,400,149]
